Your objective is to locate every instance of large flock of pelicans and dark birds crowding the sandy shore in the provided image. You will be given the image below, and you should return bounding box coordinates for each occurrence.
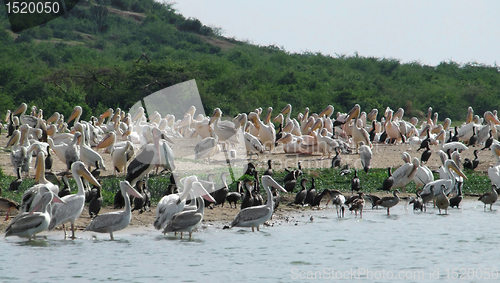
[0,103,500,240]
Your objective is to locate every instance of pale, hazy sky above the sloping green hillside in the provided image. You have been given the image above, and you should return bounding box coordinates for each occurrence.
[168,0,500,66]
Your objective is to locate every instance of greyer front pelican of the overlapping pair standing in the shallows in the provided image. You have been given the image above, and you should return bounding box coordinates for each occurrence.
[163,182,213,239]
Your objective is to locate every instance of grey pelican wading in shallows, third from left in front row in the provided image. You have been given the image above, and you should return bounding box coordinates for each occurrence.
[83,181,142,240]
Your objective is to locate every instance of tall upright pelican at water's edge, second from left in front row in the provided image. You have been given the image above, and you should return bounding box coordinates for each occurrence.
[49,161,101,239]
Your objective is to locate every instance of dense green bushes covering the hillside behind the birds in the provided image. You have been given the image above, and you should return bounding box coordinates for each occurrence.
[0,0,500,120]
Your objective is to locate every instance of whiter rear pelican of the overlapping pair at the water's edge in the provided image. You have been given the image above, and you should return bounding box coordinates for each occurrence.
[153,176,215,233]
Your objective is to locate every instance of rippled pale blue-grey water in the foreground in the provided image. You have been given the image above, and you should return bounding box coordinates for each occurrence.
[0,201,500,282]
